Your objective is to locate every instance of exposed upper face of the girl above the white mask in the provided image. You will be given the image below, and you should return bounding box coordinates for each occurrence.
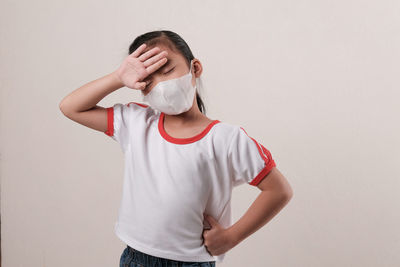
[141,44,195,95]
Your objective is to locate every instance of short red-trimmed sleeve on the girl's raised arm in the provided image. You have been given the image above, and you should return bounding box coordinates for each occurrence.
[104,102,148,151]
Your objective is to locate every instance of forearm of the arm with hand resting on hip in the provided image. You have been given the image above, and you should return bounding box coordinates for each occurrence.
[227,191,291,246]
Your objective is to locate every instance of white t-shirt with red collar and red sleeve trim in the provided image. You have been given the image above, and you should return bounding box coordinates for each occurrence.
[104,102,276,262]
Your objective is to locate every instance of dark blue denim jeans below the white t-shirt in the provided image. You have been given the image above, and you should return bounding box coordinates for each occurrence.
[119,245,215,267]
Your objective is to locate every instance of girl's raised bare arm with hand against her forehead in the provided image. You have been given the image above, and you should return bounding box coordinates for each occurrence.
[59,44,168,135]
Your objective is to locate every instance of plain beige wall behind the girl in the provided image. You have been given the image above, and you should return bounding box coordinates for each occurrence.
[0,0,400,267]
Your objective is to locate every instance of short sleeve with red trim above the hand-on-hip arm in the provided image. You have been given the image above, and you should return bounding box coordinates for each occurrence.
[228,126,276,186]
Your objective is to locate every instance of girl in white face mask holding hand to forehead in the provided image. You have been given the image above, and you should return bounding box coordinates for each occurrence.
[60,30,292,267]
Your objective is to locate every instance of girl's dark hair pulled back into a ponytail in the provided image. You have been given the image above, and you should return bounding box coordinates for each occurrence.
[129,30,206,114]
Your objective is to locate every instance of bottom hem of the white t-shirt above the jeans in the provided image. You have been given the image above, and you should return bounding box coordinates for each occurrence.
[114,223,222,262]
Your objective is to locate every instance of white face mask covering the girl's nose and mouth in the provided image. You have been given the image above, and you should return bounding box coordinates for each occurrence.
[142,60,196,115]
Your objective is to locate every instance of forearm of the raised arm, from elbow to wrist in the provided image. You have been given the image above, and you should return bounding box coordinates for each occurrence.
[60,72,124,113]
